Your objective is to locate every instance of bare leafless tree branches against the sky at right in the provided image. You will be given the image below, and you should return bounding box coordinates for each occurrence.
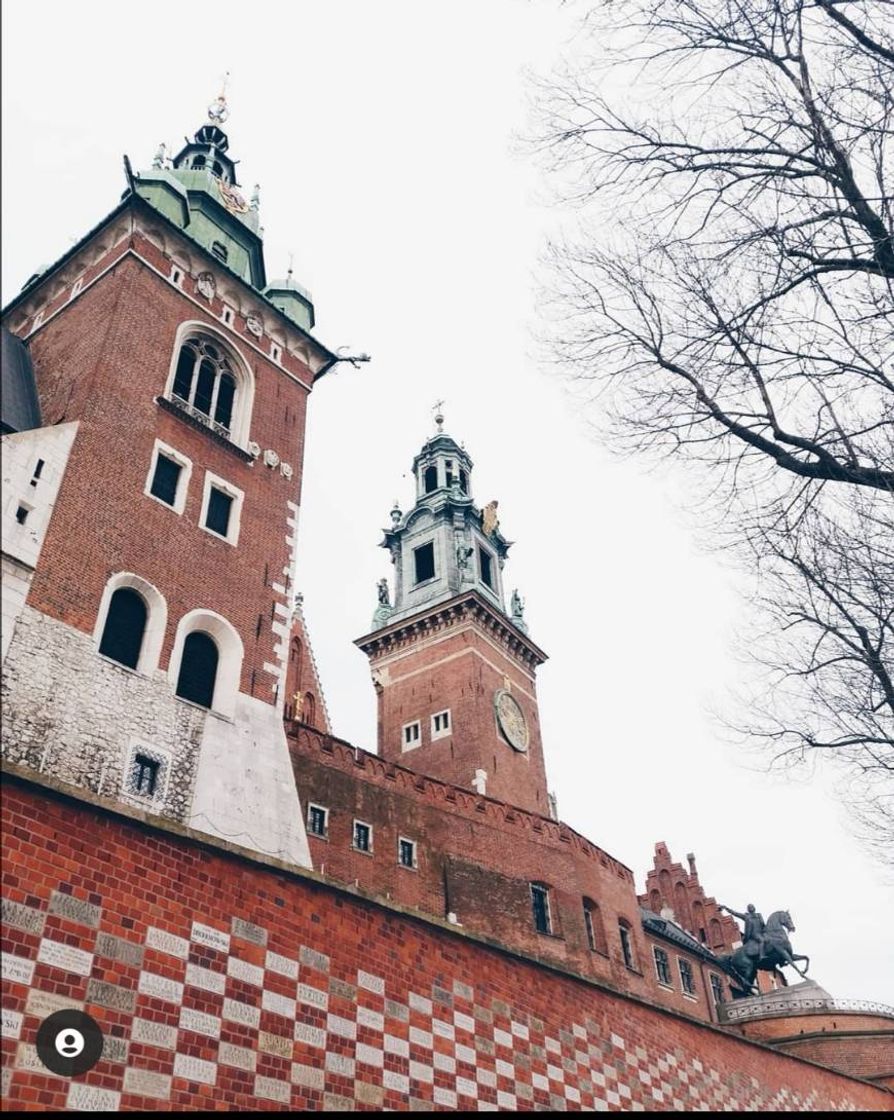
[538,0,894,850]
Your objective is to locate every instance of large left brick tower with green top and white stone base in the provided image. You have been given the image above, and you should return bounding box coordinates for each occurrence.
[3,96,337,864]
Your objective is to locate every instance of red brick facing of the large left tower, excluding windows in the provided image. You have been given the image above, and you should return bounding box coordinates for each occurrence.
[7,237,310,701]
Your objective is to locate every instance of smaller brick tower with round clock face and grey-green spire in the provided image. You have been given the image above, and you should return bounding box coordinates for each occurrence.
[356,413,549,815]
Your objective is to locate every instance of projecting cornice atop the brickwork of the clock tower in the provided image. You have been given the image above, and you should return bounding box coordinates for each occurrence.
[354,590,547,670]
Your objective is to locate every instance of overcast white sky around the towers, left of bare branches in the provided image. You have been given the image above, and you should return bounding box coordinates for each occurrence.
[2,0,894,1004]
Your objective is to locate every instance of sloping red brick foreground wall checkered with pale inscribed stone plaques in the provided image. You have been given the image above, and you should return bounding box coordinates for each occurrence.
[2,778,894,1111]
